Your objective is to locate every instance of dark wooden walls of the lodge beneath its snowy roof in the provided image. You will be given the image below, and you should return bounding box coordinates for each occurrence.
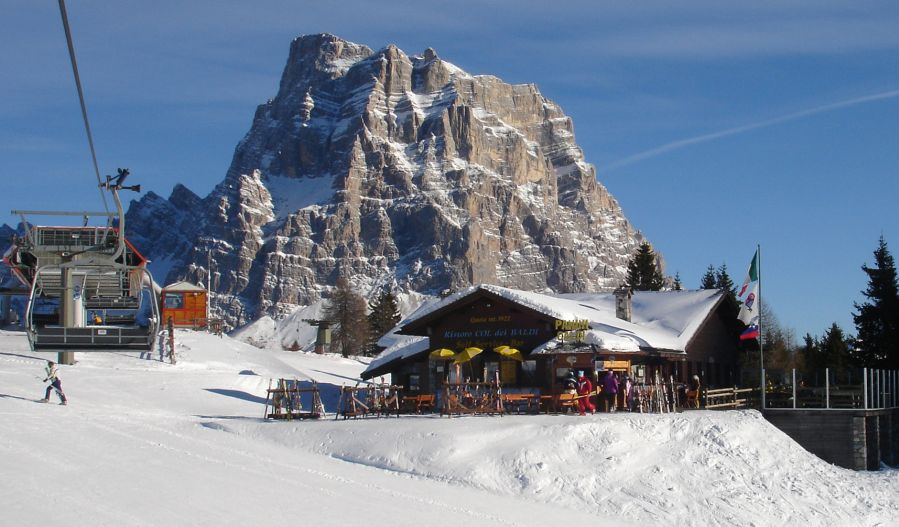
[363,288,739,394]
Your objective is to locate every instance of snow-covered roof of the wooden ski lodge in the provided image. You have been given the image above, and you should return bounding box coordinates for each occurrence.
[366,284,722,380]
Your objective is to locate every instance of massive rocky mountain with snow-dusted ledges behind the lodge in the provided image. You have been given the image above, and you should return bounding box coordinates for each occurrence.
[126,34,642,322]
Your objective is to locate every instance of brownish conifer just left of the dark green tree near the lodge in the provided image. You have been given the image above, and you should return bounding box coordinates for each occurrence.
[323,276,369,357]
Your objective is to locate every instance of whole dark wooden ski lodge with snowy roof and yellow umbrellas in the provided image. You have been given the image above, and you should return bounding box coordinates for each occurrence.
[362,285,739,402]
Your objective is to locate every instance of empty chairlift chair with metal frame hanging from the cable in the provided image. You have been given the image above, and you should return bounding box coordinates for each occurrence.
[7,169,160,352]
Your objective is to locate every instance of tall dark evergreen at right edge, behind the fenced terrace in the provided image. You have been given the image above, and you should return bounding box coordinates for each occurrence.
[853,236,899,369]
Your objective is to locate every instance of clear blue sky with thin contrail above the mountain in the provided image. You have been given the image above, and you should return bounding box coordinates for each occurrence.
[0,0,899,336]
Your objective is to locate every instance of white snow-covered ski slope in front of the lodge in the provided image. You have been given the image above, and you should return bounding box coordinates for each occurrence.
[0,331,899,527]
